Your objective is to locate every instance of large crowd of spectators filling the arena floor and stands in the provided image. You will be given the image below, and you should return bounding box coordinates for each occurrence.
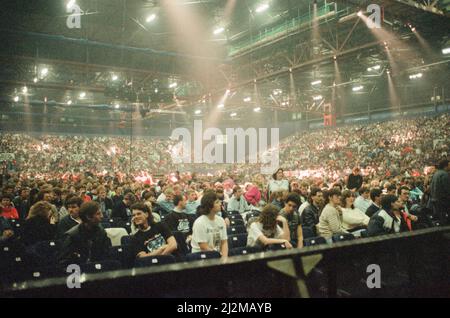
[0,114,450,284]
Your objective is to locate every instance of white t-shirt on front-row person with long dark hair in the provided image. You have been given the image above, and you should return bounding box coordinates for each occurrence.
[191,215,228,253]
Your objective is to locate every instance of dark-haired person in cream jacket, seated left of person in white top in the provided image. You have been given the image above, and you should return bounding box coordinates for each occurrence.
[317,189,347,243]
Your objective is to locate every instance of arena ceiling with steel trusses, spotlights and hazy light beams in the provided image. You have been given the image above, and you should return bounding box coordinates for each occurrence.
[0,0,450,129]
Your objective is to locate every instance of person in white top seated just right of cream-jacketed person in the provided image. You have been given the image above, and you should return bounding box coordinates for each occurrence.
[341,190,370,232]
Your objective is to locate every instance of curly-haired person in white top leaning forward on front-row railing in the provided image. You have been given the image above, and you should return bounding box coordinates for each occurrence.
[247,204,292,248]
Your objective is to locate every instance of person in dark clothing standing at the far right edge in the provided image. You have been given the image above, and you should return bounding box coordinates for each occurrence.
[430,159,450,225]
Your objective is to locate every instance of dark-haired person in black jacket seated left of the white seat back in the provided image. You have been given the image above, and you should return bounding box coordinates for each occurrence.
[58,201,112,265]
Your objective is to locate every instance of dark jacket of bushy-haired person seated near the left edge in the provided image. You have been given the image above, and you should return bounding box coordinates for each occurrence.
[22,217,56,245]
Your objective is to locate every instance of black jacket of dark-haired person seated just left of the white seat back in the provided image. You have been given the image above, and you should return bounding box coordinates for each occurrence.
[58,224,111,265]
